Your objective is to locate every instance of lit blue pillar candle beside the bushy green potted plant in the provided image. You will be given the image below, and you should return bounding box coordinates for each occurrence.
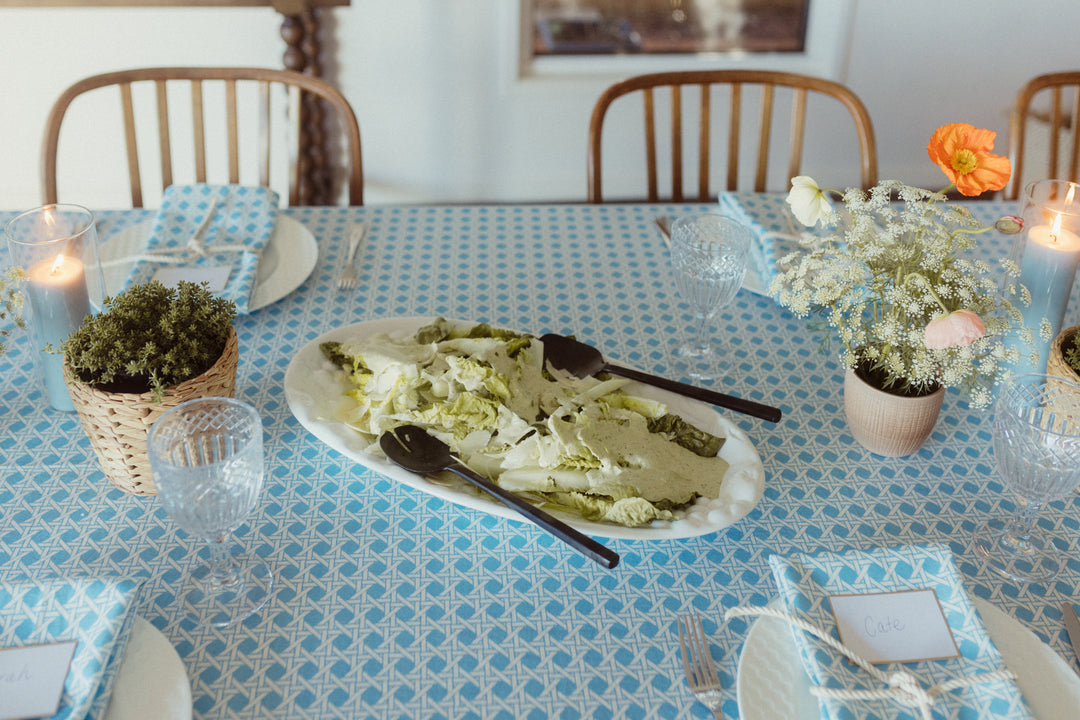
[26,255,90,412]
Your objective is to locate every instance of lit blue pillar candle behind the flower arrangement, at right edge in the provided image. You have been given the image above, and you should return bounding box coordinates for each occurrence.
[1020,214,1080,372]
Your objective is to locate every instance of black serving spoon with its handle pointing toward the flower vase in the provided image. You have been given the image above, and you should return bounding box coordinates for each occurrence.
[540,334,780,422]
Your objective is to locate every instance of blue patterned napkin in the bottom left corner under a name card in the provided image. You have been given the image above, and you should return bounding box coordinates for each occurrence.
[0,578,143,720]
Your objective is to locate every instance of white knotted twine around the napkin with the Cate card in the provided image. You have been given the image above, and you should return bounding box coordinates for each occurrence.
[724,607,1016,720]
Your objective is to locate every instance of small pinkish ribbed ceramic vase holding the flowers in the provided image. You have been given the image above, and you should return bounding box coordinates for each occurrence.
[843,368,945,458]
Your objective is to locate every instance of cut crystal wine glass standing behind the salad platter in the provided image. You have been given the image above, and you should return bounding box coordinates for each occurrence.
[671,213,752,382]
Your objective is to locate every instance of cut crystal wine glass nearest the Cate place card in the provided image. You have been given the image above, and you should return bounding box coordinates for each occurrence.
[974,373,1080,582]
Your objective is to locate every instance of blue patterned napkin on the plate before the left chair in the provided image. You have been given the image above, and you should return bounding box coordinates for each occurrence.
[124,185,278,314]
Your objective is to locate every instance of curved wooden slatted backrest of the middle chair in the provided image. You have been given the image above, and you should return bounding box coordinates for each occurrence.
[586,70,877,203]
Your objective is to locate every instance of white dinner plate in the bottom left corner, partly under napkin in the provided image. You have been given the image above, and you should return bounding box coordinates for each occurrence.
[105,617,191,720]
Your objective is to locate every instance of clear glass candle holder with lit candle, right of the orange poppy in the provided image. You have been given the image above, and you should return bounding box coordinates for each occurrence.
[1010,180,1080,372]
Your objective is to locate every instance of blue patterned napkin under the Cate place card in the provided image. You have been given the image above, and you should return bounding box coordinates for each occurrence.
[769,544,1032,720]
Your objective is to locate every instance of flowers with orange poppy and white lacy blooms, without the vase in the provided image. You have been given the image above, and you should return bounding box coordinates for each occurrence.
[770,123,1031,407]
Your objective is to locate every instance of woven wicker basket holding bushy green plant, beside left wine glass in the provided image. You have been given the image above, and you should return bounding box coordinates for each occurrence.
[64,329,240,495]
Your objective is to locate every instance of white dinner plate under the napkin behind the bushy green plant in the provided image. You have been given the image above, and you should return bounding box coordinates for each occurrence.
[100,215,319,312]
